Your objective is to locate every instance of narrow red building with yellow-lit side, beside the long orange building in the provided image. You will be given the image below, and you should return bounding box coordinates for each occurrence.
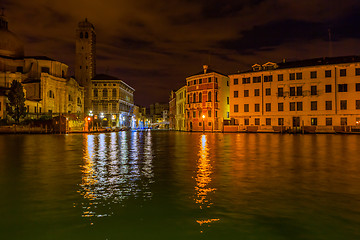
[185,65,230,131]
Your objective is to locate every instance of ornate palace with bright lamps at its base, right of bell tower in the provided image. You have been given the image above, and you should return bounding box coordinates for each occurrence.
[89,74,136,127]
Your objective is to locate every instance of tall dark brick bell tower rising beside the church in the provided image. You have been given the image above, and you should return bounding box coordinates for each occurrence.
[75,18,96,114]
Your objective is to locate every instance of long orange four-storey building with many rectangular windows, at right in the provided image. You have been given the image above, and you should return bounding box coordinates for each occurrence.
[230,56,360,132]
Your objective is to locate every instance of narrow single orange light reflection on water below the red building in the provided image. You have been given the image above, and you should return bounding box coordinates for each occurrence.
[195,135,220,232]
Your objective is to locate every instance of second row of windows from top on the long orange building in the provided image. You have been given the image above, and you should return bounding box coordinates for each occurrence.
[234,83,360,98]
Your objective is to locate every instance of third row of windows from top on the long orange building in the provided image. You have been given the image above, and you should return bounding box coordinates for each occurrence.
[234,100,360,112]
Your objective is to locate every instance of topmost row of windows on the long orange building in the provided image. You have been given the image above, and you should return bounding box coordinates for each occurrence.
[233,68,360,85]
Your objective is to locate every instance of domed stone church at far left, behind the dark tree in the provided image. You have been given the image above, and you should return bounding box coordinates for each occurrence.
[0,15,84,119]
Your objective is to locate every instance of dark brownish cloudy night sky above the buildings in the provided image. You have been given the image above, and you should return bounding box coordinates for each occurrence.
[1,0,360,106]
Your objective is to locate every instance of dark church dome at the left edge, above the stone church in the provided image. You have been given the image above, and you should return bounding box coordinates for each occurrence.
[0,16,24,58]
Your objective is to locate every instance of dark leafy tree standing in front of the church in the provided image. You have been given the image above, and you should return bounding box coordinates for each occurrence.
[6,80,26,124]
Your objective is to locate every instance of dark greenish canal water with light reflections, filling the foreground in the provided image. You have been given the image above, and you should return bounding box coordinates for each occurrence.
[0,131,360,240]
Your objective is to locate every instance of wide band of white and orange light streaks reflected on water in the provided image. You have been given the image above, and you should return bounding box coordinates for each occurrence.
[79,132,154,223]
